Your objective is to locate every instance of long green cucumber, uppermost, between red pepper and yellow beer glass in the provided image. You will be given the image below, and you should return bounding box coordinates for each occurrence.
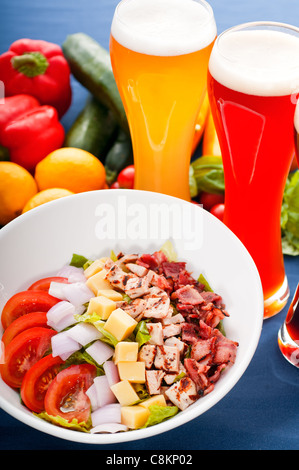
[62,33,129,134]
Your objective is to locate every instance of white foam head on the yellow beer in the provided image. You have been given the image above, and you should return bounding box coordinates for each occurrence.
[111,0,217,56]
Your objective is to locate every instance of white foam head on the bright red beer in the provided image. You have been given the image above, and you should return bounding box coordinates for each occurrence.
[209,28,299,96]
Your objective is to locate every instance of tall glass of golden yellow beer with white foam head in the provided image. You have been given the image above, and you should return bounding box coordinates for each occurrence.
[110,0,216,200]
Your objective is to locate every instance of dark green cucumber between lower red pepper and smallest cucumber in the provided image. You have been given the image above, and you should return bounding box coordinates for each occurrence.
[64,96,119,162]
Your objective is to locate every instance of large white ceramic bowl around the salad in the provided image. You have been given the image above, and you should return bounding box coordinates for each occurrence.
[0,190,264,444]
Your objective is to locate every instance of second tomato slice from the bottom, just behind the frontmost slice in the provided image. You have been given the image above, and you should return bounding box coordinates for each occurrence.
[21,354,64,413]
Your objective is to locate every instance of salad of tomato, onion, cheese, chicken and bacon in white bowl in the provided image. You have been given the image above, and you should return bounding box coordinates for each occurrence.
[0,244,238,433]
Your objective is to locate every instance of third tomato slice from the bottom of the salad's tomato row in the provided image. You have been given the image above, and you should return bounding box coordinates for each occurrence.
[0,326,57,388]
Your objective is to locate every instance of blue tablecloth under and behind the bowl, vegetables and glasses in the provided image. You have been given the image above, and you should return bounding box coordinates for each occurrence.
[0,0,299,451]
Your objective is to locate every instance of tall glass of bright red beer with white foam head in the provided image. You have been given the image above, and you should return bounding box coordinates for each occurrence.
[208,22,299,318]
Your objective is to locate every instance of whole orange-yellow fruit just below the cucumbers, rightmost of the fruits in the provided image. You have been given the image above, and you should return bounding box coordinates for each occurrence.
[35,147,106,193]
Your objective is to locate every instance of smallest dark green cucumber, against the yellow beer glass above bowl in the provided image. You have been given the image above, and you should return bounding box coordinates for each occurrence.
[105,128,133,184]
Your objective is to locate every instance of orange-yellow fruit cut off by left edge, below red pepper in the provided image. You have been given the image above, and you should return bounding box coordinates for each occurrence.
[0,162,37,225]
